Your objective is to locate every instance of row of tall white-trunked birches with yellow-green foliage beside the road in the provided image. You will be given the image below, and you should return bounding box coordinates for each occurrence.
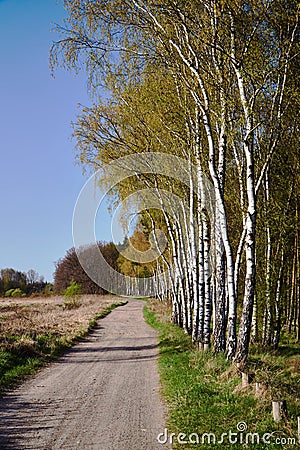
[51,0,300,364]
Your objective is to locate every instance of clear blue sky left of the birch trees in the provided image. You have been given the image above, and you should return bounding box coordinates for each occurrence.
[0,0,111,281]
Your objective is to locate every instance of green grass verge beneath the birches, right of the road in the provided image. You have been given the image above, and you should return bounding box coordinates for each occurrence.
[144,307,300,449]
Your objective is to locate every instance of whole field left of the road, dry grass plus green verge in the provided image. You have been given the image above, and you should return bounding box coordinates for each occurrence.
[0,295,124,391]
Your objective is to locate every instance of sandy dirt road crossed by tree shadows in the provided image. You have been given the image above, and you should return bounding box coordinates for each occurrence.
[0,300,165,450]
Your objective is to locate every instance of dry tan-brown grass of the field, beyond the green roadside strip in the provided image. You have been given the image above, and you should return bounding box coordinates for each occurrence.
[0,295,122,350]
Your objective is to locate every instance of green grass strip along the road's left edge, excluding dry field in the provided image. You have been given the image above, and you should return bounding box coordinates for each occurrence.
[0,302,127,394]
